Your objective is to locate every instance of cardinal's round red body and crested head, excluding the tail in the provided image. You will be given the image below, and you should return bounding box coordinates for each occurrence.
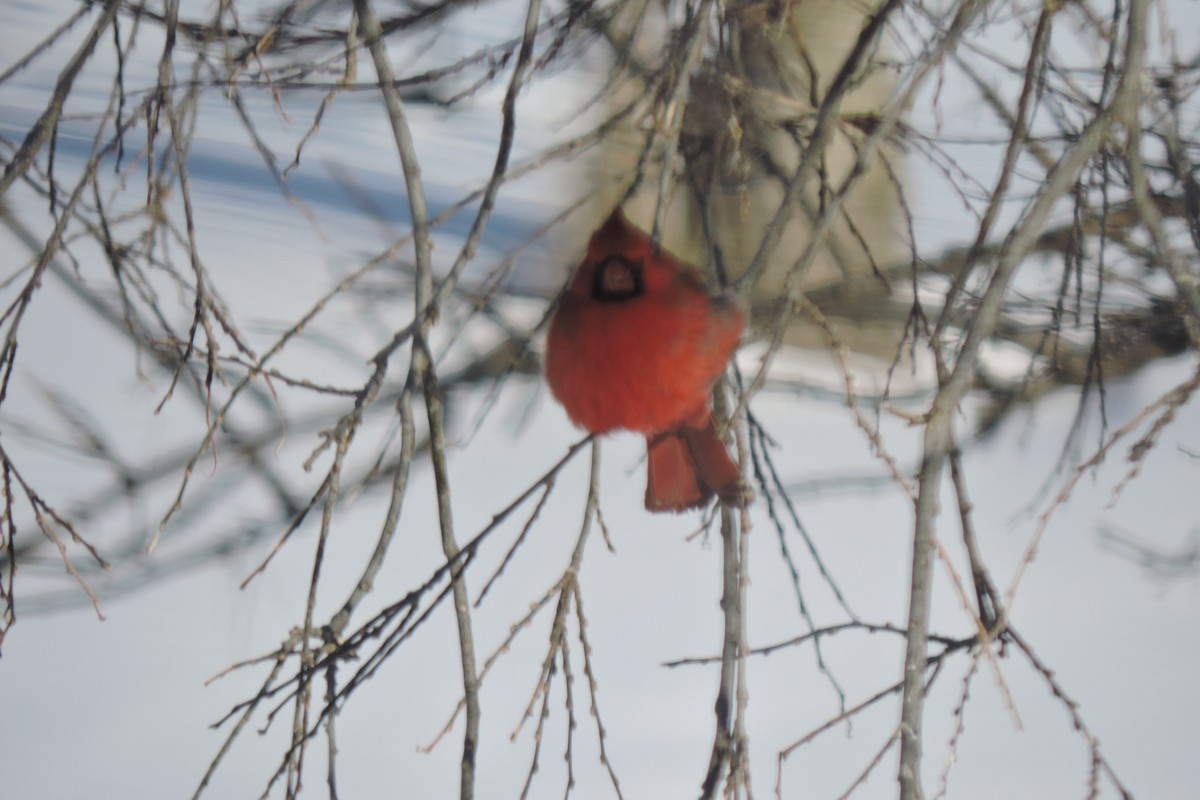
[546,209,745,433]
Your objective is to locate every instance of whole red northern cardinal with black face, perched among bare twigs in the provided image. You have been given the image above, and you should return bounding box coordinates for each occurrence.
[546,207,754,512]
